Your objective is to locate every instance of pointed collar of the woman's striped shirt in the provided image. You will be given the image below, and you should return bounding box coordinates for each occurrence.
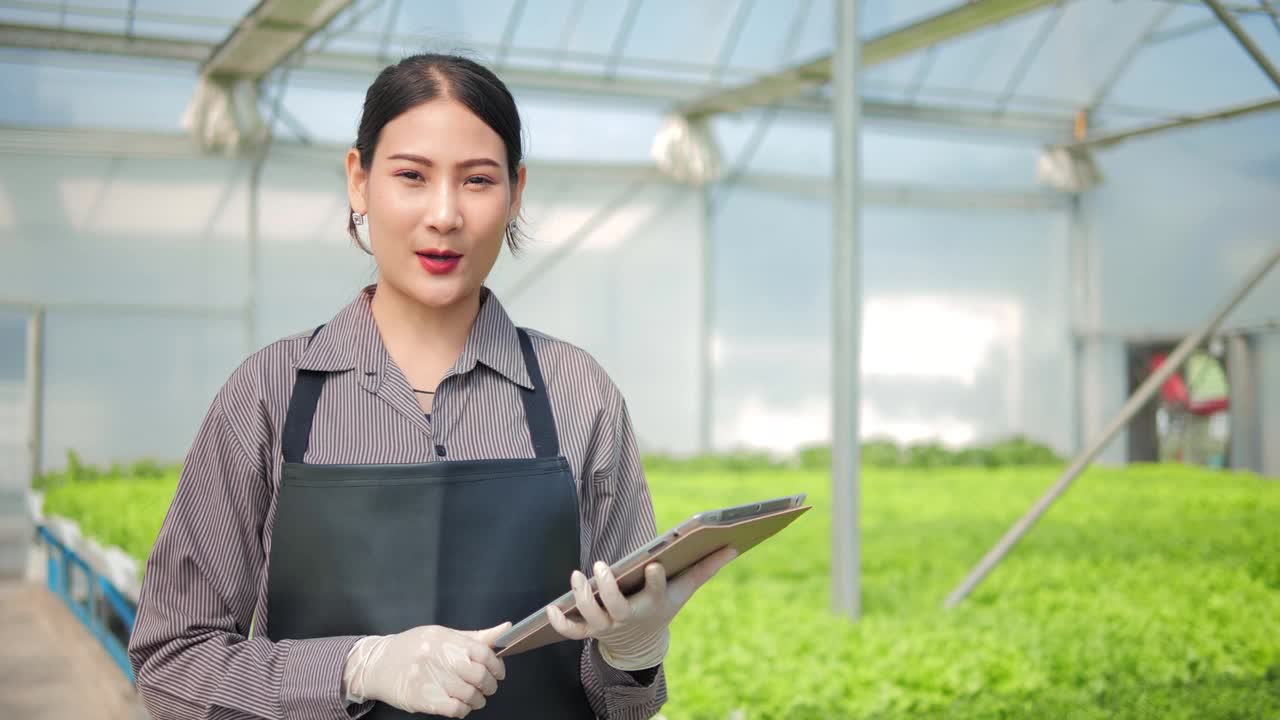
[296,286,534,391]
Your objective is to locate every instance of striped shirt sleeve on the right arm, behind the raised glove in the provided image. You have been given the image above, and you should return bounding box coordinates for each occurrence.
[582,388,667,720]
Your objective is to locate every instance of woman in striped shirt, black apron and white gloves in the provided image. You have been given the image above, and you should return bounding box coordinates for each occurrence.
[129,55,732,720]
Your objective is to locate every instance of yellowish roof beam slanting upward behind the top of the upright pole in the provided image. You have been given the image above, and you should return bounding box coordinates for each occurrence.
[678,0,1059,119]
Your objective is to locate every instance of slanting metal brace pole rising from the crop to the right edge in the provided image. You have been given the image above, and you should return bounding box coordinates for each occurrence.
[946,249,1280,607]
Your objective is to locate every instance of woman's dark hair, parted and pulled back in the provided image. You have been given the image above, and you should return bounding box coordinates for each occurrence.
[347,53,525,252]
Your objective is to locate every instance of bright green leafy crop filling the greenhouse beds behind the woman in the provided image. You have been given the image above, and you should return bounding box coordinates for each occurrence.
[40,462,1280,720]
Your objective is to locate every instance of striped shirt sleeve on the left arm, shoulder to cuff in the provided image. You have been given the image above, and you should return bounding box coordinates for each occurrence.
[128,376,371,720]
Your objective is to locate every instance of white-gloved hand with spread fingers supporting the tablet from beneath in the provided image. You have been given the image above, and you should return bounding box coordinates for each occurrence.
[547,547,737,670]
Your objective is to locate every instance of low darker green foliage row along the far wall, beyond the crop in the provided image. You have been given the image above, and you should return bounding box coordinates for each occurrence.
[644,436,1064,473]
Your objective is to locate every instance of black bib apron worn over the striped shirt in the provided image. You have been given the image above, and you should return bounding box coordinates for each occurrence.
[266,328,595,720]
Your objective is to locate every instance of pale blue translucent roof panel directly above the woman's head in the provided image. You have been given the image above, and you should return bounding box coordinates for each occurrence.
[290,0,839,83]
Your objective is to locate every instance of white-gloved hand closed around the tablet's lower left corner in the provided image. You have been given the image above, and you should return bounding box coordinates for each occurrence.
[342,623,511,717]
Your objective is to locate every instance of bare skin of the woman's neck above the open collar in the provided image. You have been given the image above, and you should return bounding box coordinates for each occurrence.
[371,279,480,379]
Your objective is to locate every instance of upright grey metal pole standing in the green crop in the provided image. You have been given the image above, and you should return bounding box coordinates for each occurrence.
[831,0,861,619]
